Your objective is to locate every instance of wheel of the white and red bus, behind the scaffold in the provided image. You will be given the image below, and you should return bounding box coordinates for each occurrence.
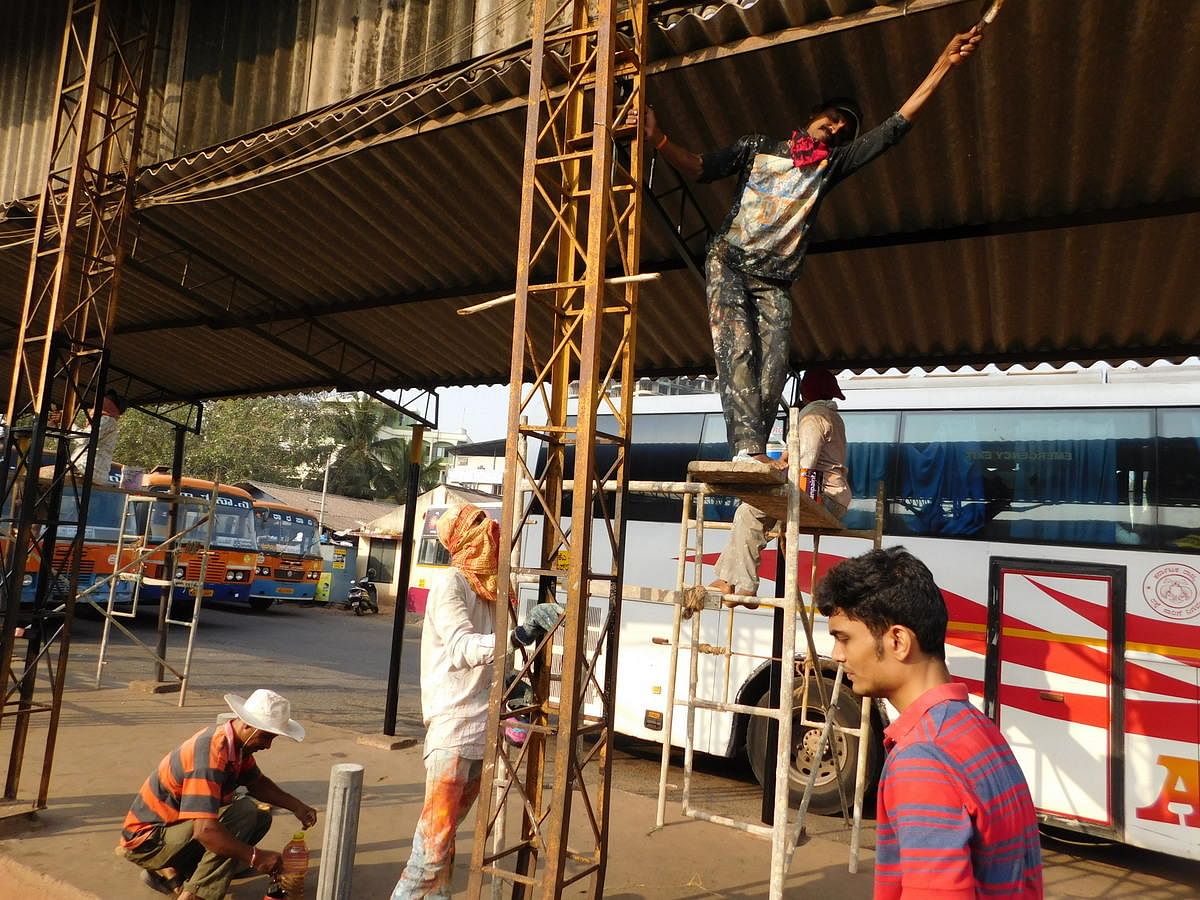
[746,677,881,816]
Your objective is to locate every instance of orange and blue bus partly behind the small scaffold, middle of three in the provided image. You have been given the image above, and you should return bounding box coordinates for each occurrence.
[136,470,258,604]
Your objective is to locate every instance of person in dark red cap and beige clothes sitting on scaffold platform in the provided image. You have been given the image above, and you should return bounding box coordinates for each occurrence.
[709,368,851,610]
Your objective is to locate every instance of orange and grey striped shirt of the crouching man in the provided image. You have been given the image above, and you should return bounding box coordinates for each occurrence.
[121,724,259,848]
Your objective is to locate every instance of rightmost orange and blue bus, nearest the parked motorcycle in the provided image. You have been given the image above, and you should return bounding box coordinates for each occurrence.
[250,500,322,611]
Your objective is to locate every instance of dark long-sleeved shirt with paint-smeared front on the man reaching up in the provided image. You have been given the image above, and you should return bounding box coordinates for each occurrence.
[700,113,912,281]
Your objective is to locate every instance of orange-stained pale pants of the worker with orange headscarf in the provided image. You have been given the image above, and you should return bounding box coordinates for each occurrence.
[391,750,484,900]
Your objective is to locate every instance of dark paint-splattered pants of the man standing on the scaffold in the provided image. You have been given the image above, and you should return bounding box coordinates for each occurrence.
[704,248,792,456]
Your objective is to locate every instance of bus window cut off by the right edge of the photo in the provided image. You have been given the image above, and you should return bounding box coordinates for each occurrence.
[1152,409,1200,553]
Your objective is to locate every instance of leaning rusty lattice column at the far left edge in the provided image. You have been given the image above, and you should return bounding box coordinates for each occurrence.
[0,0,155,809]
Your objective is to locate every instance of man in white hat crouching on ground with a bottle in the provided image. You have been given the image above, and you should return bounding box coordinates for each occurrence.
[120,690,317,900]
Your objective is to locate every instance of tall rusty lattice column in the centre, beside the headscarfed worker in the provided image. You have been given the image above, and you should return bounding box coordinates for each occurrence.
[469,0,654,898]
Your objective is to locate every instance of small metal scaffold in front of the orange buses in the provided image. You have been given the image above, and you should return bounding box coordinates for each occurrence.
[91,485,218,706]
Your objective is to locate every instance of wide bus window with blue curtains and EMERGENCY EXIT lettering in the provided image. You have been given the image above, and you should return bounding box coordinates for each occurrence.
[889,409,1153,545]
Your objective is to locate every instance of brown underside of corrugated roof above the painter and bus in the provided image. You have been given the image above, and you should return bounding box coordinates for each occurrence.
[0,0,1200,396]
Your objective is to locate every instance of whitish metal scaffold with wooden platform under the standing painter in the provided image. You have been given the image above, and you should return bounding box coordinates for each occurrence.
[656,408,883,900]
